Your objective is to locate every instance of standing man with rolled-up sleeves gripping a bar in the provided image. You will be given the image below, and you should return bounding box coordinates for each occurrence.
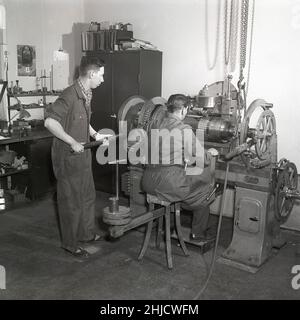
[45,57,104,257]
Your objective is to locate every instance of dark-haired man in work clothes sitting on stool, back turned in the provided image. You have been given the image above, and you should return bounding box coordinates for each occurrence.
[142,94,218,241]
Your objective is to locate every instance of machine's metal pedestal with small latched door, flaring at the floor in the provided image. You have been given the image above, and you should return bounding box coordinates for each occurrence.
[218,187,280,273]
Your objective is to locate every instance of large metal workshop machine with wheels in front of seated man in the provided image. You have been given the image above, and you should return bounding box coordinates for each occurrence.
[101,76,300,272]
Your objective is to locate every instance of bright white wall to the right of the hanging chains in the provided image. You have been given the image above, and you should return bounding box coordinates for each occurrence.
[249,0,300,170]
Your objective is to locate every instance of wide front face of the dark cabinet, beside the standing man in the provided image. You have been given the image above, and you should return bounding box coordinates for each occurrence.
[91,52,139,193]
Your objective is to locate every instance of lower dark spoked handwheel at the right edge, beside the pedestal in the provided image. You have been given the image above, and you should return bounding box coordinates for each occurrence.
[275,161,298,223]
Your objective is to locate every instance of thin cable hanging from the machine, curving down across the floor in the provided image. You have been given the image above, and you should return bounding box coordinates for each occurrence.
[193,161,229,300]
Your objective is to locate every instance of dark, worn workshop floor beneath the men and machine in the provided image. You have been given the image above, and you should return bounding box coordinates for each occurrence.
[0,193,300,300]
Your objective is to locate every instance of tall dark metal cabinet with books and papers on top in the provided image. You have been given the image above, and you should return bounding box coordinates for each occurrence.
[86,50,162,193]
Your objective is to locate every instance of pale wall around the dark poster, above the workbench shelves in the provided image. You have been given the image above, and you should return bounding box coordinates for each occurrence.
[2,0,84,117]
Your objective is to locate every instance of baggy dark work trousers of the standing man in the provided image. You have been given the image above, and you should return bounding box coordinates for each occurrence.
[54,150,96,252]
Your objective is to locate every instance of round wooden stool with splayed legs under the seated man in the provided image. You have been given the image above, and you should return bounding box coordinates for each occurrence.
[138,194,189,269]
